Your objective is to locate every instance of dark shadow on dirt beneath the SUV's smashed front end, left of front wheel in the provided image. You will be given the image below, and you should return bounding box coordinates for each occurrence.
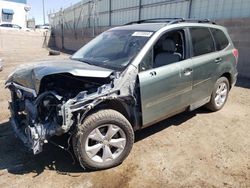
[0,122,83,175]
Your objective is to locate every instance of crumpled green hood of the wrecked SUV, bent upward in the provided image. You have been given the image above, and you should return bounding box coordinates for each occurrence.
[6,59,113,93]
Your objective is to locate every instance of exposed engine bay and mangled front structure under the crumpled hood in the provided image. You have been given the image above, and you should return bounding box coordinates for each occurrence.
[6,64,139,154]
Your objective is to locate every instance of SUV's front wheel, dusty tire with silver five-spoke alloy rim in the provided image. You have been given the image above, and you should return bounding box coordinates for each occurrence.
[72,109,134,170]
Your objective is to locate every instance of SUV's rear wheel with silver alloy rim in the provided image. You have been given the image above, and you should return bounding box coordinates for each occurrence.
[206,77,230,112]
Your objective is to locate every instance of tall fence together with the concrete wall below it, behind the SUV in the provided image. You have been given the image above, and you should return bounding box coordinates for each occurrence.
[49,0,250,77]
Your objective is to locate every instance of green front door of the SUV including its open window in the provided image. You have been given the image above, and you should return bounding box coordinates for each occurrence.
[139,31,192,127]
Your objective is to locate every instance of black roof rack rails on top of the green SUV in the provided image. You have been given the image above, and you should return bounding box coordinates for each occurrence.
[125,18,216,25]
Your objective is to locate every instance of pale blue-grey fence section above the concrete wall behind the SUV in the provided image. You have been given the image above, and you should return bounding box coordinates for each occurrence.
[49,0,250,39]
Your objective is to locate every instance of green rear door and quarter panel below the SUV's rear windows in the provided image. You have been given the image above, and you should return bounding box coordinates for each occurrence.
[191,39,237,103]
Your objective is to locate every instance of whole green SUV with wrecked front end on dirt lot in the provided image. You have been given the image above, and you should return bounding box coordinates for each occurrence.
[6,19,238,170]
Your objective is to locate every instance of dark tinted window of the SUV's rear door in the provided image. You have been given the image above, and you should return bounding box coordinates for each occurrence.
[190,28,215,56]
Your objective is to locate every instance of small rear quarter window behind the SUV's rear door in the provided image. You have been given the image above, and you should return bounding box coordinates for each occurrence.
[211,29,229,51]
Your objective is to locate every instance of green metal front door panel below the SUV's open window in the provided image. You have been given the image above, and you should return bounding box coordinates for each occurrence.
[139,60,192,127]
